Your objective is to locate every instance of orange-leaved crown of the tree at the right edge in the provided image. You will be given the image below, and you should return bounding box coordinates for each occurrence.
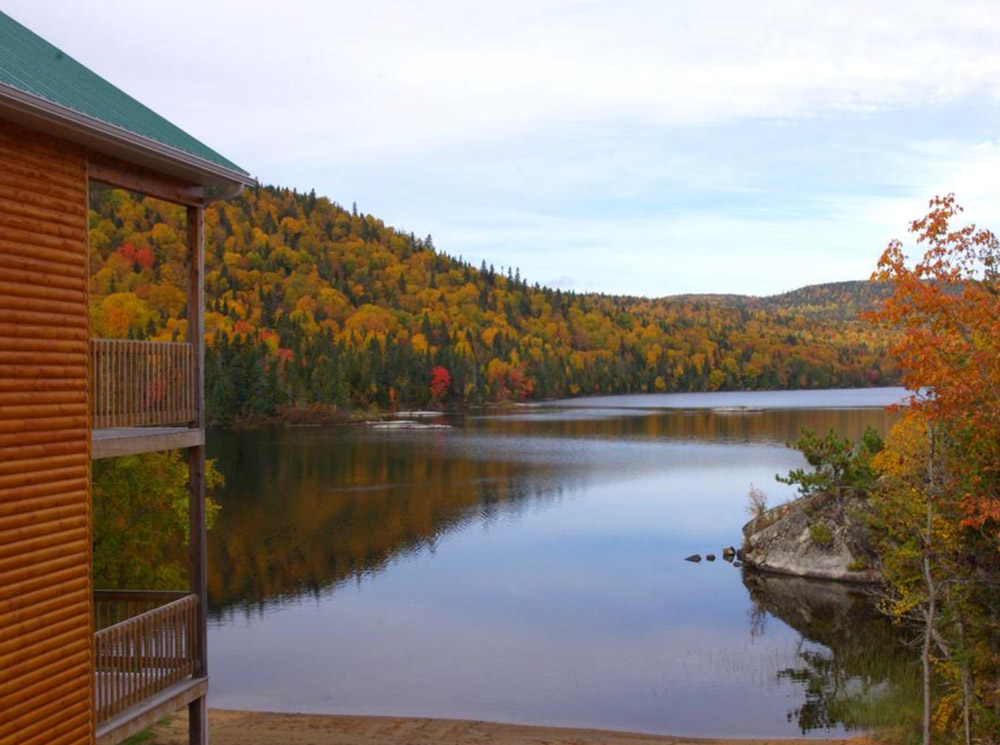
[874,195,1000,534]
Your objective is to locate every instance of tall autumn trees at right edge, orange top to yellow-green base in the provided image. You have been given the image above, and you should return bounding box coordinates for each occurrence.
[873,195,1000,744]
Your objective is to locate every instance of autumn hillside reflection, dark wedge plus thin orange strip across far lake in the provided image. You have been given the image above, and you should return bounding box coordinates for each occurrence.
[208,407,894,613]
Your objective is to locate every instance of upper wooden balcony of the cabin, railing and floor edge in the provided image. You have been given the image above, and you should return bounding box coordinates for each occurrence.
[90,339,205,458]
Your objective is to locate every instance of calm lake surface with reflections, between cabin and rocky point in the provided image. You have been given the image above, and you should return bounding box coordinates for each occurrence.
[203,389,917,736]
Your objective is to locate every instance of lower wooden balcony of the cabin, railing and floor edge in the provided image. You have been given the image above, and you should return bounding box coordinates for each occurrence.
[94,590,208,745]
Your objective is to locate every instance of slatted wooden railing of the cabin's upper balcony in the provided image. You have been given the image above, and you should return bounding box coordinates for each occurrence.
[90,339,197,429]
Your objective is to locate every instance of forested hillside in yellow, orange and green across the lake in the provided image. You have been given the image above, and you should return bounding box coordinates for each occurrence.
[90,187,896,422]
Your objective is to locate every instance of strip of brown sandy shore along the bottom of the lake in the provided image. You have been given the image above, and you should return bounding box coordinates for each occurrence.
[146,709,875,745]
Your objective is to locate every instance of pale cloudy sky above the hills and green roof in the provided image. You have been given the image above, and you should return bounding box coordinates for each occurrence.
[2,0,1000,296]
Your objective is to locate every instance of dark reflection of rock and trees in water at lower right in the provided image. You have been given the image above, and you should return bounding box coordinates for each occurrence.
[743,572,920,734]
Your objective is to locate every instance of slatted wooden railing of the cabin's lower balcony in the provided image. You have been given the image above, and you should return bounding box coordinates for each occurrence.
[94,590,198,725]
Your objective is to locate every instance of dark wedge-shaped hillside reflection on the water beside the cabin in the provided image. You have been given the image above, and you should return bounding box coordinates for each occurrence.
[208,429,574,612]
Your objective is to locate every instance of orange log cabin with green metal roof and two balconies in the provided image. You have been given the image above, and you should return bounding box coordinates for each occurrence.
[0,13,254,745]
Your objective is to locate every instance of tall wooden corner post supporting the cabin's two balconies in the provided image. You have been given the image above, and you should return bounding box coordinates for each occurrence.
[187,206,208,745]
